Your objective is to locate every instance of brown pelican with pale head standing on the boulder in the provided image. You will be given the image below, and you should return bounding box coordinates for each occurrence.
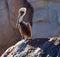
[17,7,31,40]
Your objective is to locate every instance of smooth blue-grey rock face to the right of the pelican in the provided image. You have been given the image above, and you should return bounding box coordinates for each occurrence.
[27,0,60,38]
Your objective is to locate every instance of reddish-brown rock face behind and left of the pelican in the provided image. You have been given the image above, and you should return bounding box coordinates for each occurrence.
[0,0,33,55]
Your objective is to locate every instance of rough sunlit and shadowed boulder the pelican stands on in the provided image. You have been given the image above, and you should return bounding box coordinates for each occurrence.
[1,38,60,57]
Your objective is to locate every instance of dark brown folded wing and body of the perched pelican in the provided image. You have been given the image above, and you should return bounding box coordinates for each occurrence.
[20,24,31,38]
